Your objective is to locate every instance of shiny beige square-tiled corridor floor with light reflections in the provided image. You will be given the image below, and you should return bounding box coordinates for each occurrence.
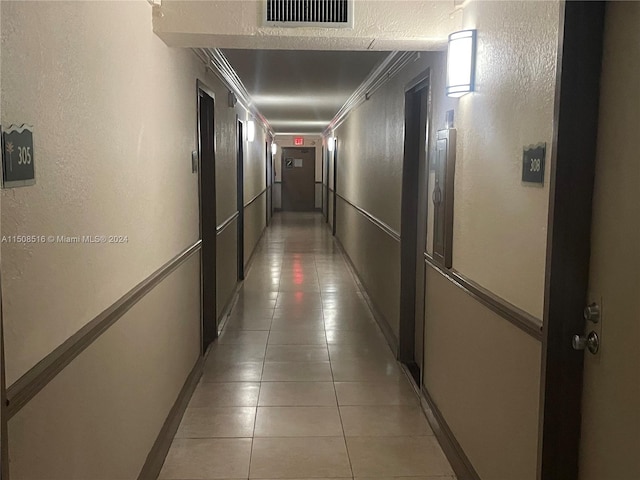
[159,214,455,480]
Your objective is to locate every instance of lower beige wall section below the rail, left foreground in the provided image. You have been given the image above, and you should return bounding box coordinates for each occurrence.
[9,254,200,480]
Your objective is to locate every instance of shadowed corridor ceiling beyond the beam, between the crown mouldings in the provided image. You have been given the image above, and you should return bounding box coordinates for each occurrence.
[222,49,389,134]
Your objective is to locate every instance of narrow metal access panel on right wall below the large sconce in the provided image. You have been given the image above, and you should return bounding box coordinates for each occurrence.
[431,128,456,268]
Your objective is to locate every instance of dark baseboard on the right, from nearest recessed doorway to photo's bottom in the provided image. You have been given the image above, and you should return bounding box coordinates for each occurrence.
[420,385,480,480]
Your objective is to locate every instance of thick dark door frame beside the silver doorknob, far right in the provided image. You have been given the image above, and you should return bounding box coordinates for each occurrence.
[538,1,605,480]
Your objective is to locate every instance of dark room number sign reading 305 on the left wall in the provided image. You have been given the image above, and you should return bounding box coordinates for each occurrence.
[2,125,36,187]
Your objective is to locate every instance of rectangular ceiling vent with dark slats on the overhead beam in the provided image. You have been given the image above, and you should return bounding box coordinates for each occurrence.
[264,0,354,28]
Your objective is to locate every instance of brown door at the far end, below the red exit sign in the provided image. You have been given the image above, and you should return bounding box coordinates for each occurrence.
[282,148,316,212]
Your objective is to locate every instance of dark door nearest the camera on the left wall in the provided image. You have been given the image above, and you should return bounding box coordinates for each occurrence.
[198,85,218,353]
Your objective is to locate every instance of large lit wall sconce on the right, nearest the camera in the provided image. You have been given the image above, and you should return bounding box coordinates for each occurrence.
[447,30,476,97]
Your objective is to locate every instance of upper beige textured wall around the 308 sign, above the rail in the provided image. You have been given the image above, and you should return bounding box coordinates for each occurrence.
[453,1,559,318]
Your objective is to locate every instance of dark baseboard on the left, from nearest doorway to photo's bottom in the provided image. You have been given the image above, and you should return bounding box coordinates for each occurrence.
[138,357,205,480]
